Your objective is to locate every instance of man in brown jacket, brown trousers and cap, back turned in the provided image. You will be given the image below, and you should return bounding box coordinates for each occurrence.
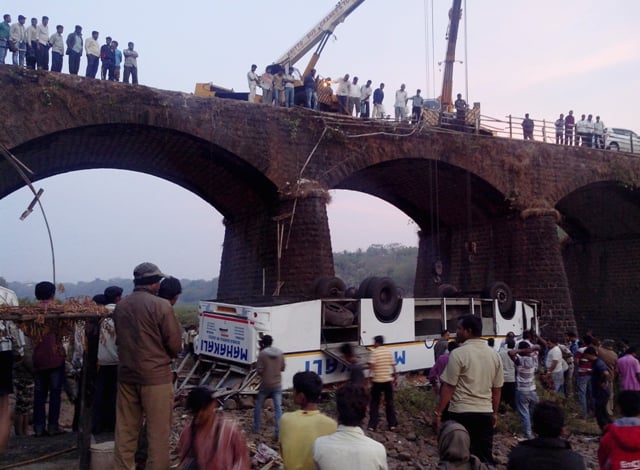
[113,262,182,470]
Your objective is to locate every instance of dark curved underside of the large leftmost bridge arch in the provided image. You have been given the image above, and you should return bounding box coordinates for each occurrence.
[0,123,277,218]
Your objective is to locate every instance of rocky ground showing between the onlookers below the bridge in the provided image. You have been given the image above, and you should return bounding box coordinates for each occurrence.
[0,376,598,470]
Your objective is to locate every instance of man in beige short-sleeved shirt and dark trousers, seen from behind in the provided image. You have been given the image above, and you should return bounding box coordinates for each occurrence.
[434,315,504,464]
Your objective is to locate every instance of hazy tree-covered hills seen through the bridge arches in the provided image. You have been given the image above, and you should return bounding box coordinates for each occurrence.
[0,243,418,305]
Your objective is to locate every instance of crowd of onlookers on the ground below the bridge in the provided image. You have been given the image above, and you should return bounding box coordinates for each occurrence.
[0,280,640,470]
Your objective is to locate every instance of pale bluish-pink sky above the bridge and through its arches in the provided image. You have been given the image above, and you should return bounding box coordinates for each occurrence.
[0,0,640,282]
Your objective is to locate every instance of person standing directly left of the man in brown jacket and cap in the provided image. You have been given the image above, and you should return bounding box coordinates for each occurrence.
[91,286,123,434]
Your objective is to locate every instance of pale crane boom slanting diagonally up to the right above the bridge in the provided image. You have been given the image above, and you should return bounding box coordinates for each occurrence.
[275,0,364,74]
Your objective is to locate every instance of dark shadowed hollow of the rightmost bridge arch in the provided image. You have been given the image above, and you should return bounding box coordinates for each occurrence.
[556,180,640,339]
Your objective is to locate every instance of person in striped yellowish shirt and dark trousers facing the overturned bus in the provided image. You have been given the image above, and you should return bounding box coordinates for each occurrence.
[367,335,398,431]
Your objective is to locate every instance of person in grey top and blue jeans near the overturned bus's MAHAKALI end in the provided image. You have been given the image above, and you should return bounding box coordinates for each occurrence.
[253,335,285,441]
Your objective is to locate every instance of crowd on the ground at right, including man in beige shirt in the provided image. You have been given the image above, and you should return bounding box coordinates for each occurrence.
[429,317,640,469]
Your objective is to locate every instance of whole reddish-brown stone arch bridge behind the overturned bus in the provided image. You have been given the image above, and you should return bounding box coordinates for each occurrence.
[0,66,640,340]
